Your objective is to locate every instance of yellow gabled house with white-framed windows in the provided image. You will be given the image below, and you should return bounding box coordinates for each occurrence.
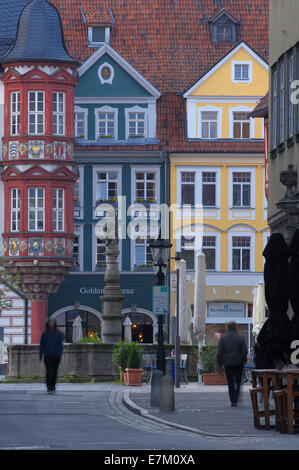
[170,42,269,345]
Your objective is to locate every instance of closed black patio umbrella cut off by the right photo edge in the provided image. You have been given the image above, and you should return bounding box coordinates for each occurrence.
[287,229,299,352]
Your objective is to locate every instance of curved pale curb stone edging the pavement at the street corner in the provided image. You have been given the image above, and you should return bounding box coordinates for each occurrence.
[122,390,256,438]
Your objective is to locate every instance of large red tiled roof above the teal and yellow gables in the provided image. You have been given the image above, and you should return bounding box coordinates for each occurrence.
[52,0,269,152]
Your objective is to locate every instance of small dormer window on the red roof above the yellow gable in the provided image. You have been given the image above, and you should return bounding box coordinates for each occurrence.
[210,10,238,42]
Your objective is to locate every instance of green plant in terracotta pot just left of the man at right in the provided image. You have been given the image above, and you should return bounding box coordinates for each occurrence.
[198,346,227,385]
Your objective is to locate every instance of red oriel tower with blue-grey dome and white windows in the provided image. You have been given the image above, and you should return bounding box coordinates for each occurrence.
[1,0,78,344]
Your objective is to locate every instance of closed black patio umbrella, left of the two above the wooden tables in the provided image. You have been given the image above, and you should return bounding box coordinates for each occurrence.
[257,233,289,364]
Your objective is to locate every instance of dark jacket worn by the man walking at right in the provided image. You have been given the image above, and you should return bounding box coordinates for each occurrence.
[217,331,248,366]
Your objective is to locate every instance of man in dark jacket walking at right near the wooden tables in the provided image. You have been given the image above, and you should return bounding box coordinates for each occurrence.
[217,322,248,406]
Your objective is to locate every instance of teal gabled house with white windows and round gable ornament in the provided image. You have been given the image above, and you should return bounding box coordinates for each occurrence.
[49,43,169,343]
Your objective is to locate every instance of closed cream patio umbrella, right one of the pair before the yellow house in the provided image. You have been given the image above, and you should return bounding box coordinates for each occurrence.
[194,253,206,348]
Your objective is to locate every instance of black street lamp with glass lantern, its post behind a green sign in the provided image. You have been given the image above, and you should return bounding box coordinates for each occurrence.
[149,233,172,374]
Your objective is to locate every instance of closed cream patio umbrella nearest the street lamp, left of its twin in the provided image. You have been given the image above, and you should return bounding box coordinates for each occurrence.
[179,259,192,344]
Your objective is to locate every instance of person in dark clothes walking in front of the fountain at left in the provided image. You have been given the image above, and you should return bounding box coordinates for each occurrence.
[39,318,64,394]
